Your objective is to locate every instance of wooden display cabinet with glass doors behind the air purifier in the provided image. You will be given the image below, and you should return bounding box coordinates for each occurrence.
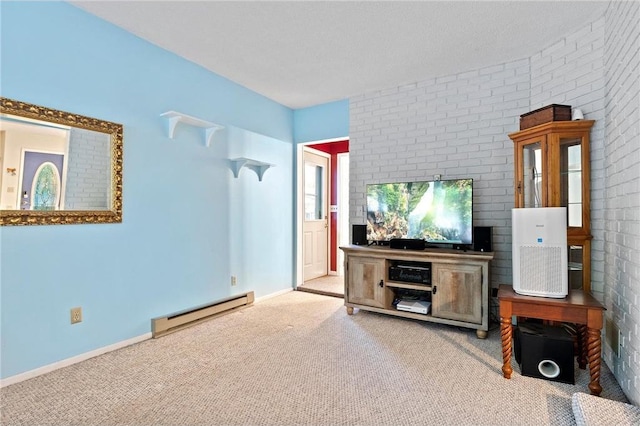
[509,120,594,292]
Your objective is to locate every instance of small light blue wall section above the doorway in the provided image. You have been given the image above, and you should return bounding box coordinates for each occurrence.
[293,99,349,143]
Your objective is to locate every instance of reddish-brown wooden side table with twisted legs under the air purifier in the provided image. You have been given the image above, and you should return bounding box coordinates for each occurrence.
[498,285,604,396]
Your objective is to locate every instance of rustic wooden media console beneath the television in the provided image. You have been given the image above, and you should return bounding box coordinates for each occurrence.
[341,245,493,338]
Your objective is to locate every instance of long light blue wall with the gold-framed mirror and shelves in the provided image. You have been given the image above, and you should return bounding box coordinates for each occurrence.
[0,2,294,378]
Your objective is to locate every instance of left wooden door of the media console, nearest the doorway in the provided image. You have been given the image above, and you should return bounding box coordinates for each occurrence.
[347,256,391,308]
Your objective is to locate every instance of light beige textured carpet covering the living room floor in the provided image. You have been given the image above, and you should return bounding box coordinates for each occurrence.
[0,291,626,425]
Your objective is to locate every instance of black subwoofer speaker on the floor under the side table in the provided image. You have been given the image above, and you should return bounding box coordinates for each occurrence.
[514,323,575,384]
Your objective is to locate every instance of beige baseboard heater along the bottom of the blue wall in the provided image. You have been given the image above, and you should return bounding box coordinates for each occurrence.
[151,291,254,338]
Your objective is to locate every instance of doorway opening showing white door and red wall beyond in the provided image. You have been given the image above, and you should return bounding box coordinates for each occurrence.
[295,139,349,297]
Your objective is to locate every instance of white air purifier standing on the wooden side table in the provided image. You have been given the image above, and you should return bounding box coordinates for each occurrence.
[511,207,569,298]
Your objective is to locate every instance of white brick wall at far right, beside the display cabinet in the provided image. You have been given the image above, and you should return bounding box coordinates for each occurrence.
[601,2,640,404]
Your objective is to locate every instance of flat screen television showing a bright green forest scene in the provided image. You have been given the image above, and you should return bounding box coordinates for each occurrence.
[367,179,473,245]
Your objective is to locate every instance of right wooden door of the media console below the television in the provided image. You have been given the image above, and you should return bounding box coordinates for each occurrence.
[431,264,482,324]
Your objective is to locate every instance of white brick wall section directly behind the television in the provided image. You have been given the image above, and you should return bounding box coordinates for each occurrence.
[349,59,529,283]
